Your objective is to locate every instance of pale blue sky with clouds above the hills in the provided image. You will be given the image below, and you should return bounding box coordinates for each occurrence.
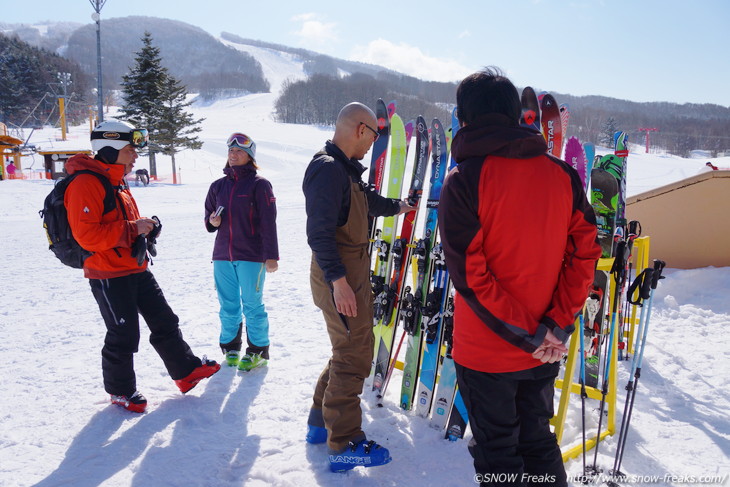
[5,0,730,106]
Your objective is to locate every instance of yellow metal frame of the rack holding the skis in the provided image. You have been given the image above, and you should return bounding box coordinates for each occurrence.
[550,237,649,463]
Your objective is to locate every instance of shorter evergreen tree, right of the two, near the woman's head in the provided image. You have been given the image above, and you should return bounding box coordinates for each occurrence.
[155,76,205,184]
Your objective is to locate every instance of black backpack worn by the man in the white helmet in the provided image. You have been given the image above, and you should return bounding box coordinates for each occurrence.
[38,170,117,269]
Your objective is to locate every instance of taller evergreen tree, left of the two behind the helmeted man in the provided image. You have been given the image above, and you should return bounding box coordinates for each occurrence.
[120,32,169,176]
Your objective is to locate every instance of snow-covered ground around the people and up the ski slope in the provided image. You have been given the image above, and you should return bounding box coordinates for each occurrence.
[0,43,730,487]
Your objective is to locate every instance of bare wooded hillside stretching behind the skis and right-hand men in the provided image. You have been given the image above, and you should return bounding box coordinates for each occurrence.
[275,71,730,157]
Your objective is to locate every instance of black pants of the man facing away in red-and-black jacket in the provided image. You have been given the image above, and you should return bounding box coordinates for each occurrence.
[456,363,568,487]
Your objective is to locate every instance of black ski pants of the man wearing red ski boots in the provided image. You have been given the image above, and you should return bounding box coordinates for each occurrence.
[89,270,201,396]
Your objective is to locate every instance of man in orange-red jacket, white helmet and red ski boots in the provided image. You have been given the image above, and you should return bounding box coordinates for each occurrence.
[64,120,220,413]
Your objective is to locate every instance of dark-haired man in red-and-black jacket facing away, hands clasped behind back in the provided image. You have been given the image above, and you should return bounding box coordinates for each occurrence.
[439,68,601,486]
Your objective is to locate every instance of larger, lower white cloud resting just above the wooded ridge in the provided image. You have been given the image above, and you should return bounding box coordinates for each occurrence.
[350,39,474,81]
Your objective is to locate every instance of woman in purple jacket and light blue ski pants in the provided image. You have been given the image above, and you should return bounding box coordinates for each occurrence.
[205,133,279,371]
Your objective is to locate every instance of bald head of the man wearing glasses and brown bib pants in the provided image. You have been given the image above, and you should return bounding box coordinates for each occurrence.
[332,102,378,160]
